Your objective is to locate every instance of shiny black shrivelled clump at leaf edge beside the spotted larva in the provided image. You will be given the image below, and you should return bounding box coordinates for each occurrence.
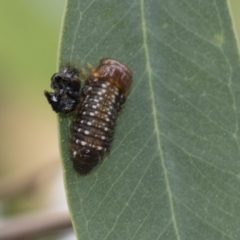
[44,66,81,113]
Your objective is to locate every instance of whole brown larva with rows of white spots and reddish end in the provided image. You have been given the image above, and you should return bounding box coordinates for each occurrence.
[70,58,132,174]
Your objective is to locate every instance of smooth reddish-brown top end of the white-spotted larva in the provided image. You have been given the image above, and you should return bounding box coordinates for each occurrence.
[93,58,132,96]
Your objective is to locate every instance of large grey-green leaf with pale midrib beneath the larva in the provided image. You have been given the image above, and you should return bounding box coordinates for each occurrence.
[59,0,240,240]
